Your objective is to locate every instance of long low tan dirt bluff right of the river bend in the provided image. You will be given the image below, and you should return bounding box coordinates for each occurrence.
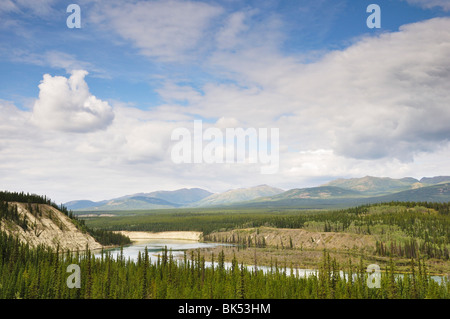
[205,227,375,250]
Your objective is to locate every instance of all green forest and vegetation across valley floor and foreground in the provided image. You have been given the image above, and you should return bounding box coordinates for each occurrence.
[0,193,450,299]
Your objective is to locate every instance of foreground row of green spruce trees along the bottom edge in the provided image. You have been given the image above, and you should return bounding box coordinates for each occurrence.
[0,233,450,299]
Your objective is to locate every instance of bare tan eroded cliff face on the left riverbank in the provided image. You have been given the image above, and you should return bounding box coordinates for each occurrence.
[0,202,102,251]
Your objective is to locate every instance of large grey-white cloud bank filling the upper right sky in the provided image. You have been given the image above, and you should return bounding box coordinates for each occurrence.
[196,18,450,161]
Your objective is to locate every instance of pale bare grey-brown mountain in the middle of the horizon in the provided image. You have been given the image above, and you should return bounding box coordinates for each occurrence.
[192,185,283,207]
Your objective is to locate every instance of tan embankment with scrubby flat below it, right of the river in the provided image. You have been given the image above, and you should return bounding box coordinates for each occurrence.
[197,227,375,269]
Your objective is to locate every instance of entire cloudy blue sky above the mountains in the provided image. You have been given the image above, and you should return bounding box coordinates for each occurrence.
[0,0,450,203]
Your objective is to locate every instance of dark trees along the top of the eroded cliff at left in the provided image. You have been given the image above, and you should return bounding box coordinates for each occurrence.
[0,192,131,246]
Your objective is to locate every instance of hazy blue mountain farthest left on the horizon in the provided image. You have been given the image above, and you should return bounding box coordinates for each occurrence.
[64,188,212,211]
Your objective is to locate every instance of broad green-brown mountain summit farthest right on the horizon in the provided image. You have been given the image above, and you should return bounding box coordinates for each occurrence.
[323,176,424,195]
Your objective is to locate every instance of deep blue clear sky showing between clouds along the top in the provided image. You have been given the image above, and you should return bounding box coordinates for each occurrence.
[0,0,449,108]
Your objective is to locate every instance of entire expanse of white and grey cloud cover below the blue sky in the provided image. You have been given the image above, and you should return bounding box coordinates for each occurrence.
[0,1,450,201]
